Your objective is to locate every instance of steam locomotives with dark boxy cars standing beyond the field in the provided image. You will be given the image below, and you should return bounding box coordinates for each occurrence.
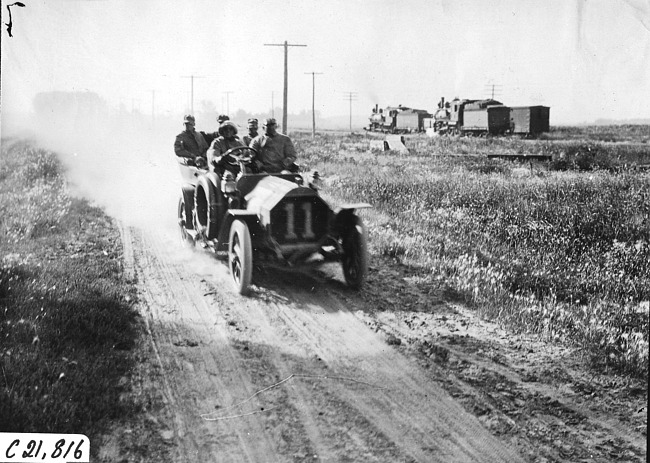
[366,98,550,137]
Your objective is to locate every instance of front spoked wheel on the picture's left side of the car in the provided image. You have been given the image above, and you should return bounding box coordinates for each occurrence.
[228,220,253,294]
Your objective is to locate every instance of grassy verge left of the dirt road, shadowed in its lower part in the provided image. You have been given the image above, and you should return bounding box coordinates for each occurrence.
[0,139,138,438]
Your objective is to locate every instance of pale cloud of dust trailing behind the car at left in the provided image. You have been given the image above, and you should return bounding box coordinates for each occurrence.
[2,101,248,286]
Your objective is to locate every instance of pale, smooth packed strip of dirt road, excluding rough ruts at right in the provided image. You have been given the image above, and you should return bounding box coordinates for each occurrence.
[116,223,521,462]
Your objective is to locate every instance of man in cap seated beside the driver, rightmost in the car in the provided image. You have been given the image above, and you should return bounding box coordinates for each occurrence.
[250,118,296,174]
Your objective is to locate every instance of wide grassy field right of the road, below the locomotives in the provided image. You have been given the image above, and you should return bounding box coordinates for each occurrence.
[296,130,650,377]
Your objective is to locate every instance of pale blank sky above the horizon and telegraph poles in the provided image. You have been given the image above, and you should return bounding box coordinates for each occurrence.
[1,0,650,124]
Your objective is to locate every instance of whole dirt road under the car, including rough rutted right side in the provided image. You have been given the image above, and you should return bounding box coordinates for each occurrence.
[100,222,647,462]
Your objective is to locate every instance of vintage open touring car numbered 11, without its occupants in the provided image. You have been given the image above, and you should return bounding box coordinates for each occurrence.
[178,146,371,294]
